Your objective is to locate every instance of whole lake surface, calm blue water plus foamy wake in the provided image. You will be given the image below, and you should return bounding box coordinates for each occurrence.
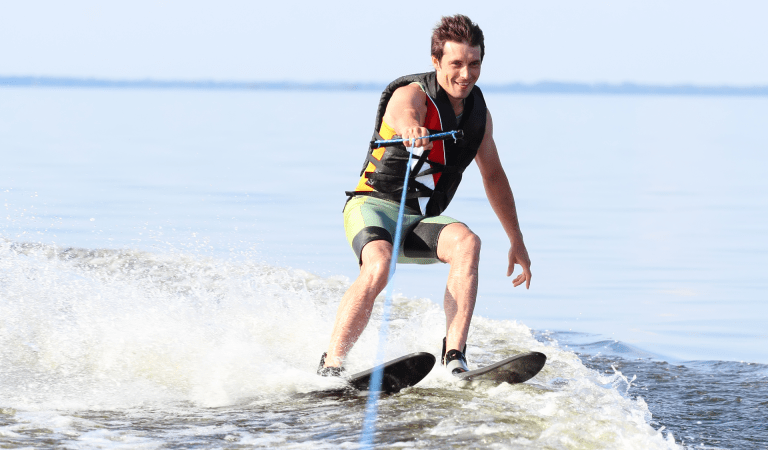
[0,85,768,449]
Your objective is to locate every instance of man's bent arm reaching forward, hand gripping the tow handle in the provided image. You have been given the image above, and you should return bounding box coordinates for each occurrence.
[384,84,432,149]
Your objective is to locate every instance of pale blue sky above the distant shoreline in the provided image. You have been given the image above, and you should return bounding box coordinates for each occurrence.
[0,0,768,86]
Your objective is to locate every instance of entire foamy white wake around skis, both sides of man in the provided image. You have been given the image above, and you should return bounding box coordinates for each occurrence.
[0,240,676,449]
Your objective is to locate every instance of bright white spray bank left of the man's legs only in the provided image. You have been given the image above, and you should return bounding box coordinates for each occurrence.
[0,242,352,408]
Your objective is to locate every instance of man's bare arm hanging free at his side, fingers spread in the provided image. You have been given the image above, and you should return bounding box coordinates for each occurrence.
[475,111,531,289]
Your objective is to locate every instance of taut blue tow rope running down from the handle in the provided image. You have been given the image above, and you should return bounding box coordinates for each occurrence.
[360,141,413,448]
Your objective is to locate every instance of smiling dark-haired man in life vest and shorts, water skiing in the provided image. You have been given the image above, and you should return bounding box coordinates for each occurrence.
[318,15,531,376]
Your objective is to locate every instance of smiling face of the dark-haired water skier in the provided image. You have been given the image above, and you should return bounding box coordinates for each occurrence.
[432,41,481,99]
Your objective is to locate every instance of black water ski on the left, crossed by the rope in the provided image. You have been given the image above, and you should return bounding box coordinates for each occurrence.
[347,352,435,394]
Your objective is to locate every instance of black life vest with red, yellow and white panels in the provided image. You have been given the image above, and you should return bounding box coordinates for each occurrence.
[347,72,487,216]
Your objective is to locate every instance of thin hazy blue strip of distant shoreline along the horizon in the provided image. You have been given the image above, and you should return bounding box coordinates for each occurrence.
[0,76,768,97]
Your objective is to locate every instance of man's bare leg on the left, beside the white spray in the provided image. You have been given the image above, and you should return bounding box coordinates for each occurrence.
[325,240,392,367]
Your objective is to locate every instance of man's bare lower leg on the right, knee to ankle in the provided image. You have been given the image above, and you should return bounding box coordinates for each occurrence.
[437,223,480,351]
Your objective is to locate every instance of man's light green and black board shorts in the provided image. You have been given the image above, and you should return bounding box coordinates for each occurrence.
[344,195,461,264]
